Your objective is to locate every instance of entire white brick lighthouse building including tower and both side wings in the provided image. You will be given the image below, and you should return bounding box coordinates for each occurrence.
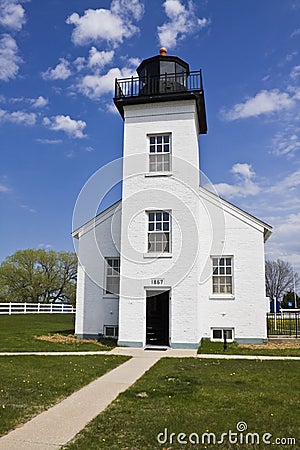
[73,48,271,348]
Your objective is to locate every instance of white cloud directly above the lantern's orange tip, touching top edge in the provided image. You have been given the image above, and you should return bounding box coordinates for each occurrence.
[157,0,210,48]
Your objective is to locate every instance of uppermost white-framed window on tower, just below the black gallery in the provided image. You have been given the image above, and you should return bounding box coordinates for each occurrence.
[149,134,171,172]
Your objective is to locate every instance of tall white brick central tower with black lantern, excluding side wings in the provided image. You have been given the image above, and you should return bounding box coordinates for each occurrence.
[115,48,207,347]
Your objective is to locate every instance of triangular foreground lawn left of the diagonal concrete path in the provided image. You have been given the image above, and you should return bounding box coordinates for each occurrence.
[0,355,128,435]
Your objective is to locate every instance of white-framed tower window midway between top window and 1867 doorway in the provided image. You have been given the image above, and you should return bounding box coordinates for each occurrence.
[148,211,171,253]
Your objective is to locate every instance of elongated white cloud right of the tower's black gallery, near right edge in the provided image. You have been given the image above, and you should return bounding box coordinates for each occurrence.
[221,89,295,121]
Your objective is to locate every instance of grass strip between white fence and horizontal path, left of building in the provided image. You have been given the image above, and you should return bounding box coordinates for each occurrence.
[0,314,112,352]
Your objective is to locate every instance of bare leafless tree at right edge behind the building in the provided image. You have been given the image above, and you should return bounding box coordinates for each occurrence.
[266,259,299,299]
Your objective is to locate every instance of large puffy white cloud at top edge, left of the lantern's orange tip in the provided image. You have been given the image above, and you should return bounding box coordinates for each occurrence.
[66,0,143,47]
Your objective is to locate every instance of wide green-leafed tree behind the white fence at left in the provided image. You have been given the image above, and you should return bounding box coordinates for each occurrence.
[0,249,77,304]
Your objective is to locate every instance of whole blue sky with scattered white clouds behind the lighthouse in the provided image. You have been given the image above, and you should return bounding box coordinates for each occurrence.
[0,0,300,272]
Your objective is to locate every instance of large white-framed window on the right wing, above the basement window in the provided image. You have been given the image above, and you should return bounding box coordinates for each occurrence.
[212,257,233,294]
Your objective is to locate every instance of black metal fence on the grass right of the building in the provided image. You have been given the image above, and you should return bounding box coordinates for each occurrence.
[267,312,300,338]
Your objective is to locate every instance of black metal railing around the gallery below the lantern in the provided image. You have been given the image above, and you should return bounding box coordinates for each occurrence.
[115,70,203,99]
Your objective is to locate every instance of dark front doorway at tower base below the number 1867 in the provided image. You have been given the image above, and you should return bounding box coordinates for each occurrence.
[146,291,169,345]
